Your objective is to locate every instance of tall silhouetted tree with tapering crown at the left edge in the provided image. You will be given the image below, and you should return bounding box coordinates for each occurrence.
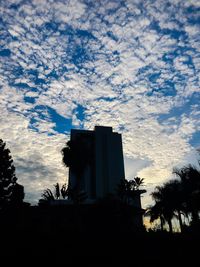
[0,139,24,208]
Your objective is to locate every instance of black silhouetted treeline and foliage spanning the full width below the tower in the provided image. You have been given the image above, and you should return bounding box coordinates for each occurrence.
[0,140,200,266]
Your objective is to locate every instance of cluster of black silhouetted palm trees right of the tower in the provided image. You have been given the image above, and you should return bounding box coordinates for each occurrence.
[147,161,200,232]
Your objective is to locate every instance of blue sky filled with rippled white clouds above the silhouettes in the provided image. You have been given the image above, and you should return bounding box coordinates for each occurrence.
[0,0,200,207]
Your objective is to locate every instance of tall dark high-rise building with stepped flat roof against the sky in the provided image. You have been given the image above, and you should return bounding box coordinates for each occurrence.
[69,126,125,200]
